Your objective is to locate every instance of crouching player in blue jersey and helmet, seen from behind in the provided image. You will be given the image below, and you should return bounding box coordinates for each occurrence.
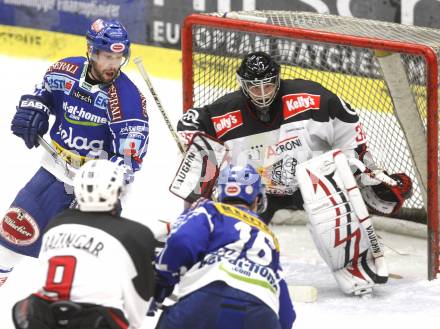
[156,165,296,329]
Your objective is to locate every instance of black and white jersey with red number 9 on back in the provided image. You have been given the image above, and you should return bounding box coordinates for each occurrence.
[38,210,155,323]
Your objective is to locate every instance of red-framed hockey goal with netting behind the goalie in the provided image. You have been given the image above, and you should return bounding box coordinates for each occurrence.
[182,11,440,279]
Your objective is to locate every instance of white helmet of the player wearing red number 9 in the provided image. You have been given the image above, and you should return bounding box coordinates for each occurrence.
[73,159,125,211]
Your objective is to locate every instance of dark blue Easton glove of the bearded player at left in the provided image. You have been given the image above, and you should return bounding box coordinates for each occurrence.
[11,95,50,149]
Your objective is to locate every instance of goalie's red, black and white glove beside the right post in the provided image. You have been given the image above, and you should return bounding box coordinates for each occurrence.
[349,159,413,215]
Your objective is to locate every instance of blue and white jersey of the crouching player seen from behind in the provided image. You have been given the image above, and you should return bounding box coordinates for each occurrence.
[156,201,294,328]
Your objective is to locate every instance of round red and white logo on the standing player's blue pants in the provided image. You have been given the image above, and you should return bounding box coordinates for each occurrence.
[0,207,40,246]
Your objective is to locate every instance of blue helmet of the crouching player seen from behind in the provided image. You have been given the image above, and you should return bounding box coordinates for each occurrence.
[217,164,267,213]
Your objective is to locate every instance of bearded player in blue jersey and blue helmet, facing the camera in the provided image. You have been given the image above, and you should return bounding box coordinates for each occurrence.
[0,19,149,285]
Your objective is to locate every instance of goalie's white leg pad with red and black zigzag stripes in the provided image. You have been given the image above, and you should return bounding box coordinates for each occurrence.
[297,150,388,294]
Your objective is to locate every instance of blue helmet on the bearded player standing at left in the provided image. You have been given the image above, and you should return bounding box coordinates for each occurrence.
[86,18,130,61]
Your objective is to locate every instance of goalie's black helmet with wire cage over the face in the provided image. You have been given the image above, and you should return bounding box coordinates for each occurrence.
[237,52,280,112]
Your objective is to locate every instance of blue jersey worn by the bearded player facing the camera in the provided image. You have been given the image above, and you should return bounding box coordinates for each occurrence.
[34,57,149,171]
